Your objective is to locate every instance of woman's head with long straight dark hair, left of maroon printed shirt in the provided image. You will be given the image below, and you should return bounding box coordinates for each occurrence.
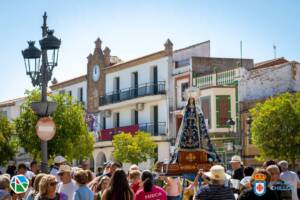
[107,169,133,199]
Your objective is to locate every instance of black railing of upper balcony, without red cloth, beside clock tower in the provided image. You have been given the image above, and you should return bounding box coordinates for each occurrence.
[99,81,166,106]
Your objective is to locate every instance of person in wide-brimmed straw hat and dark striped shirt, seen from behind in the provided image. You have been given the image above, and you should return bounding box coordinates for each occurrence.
[194,165,235,200]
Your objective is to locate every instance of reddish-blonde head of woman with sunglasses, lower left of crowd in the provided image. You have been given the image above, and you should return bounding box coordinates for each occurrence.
[39,174,57,196]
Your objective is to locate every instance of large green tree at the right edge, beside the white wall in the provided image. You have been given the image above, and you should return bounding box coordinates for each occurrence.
[250,93,300,167]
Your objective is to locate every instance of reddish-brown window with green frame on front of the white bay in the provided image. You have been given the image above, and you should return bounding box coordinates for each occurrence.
[216,95,231,128]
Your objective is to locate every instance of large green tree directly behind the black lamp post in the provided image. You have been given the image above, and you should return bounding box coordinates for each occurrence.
[15,90,94,160]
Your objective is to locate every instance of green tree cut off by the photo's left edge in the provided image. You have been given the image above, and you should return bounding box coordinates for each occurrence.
[0,115,17,165]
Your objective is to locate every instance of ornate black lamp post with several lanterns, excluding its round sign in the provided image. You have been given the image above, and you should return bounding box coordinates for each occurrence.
[22,12,61,172]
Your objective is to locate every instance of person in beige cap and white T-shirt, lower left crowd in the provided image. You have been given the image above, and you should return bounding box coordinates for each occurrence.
[57,165,78,200]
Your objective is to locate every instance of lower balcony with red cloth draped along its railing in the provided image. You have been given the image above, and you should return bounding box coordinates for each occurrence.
[98,122,166,141]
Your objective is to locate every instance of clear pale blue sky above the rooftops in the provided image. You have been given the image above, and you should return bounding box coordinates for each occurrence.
[0,0,300,101]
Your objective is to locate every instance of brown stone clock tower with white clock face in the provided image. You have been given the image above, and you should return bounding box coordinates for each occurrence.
[87,38,110,113]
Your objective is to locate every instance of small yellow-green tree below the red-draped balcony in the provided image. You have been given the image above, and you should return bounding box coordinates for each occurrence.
[112,131,157,164]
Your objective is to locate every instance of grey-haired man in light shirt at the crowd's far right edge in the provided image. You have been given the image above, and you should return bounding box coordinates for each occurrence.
[278,160,300,200]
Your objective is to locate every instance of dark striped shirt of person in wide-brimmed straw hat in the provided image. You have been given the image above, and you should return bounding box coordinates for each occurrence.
[195,184,235,200]
